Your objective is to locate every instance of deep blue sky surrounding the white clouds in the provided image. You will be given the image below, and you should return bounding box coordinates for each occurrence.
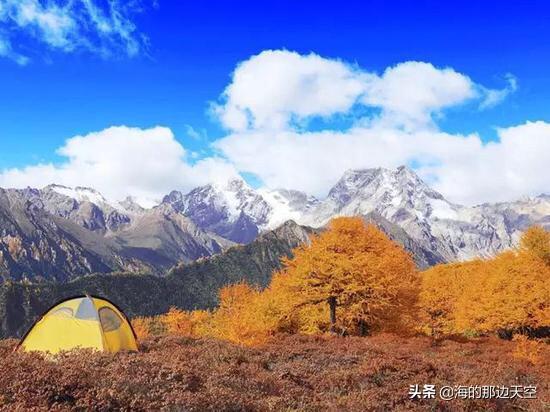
[0,0,550,202]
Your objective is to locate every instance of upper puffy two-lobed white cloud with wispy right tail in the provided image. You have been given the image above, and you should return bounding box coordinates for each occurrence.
[214,50,515,131]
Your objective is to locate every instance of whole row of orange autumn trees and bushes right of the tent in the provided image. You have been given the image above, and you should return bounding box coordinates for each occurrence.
[134,224,550,346]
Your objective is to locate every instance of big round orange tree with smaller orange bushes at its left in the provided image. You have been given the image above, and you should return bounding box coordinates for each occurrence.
[166,218,418,345]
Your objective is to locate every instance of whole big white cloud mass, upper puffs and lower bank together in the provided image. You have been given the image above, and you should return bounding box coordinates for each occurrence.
[214,51,550,204]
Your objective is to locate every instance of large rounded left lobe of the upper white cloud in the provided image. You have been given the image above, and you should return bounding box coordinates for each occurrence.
[215,50,374,130]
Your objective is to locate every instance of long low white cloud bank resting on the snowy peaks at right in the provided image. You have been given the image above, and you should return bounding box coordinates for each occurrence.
[215,122,550,204]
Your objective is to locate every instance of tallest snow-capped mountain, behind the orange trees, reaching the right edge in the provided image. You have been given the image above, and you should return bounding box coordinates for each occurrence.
[301,166,550,261]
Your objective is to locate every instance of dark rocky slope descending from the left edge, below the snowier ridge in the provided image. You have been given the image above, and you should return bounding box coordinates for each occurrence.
[0,190,132,281]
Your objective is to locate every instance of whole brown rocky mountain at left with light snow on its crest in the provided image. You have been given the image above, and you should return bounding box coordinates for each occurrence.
[0,186,233,281]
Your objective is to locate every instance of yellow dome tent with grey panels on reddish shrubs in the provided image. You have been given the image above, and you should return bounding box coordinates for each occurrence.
[16,295,137,354]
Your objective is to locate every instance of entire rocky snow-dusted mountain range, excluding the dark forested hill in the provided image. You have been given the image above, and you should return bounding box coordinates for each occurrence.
[0,166,550,282]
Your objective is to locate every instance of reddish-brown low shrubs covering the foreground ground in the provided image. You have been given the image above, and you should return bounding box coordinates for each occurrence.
[0,335,550,411]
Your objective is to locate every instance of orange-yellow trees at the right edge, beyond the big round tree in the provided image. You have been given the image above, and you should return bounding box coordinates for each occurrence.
[420,228,550,334]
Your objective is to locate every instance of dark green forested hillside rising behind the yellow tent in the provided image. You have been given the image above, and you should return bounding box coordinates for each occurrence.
[0,222,311,337]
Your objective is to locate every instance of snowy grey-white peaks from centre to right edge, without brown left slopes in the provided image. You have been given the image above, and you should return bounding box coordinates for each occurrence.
[164,166,550,261]
